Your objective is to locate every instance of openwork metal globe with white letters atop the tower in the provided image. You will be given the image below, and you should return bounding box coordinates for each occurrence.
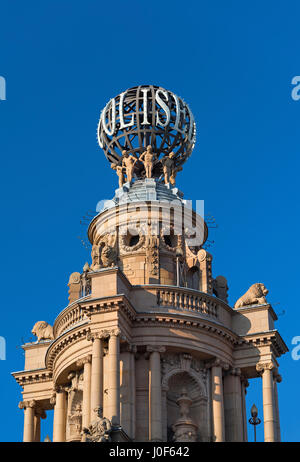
[98,85,196,177]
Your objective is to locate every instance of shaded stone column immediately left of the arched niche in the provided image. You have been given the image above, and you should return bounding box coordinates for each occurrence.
[147,346,166,441]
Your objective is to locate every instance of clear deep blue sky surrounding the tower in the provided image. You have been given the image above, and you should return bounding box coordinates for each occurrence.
[0,0,300,441]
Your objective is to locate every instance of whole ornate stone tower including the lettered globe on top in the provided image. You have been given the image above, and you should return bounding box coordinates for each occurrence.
[13,85,287,442]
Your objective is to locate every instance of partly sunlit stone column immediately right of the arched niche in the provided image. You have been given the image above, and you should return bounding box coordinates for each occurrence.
[210,359,228,443]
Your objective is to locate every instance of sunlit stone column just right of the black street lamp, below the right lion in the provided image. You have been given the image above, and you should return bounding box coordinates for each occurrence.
[256,362,276,442]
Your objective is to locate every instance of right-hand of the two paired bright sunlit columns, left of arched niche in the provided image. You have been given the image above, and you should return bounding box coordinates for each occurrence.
[107,328,121,424]
